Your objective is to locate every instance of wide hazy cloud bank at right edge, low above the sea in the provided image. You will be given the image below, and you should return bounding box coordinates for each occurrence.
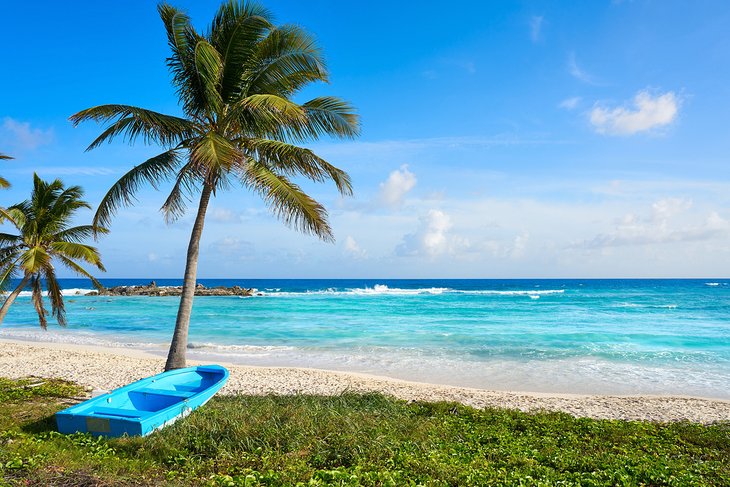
[573,198,730,249]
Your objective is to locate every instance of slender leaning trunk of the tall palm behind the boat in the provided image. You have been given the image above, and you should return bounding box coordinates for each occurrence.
[165,183,213,370]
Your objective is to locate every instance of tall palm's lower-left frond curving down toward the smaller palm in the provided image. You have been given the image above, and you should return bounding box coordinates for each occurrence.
[93,149,180,227]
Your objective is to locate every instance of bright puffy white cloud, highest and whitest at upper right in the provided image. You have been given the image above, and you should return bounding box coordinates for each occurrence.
[590,91,679,135]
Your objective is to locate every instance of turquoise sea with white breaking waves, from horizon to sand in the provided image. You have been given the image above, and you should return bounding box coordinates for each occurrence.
[0,279,730,399]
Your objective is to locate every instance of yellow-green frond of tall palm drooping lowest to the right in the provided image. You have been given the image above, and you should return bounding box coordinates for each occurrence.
[241,161,334,241]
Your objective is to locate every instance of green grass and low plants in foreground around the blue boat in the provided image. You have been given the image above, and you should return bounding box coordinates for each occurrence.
[0,380,730,486]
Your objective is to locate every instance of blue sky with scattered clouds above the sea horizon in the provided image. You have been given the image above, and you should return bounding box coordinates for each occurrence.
[0,0,730,278]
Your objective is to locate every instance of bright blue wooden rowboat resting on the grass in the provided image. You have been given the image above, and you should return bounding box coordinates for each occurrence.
[56,365,228,437]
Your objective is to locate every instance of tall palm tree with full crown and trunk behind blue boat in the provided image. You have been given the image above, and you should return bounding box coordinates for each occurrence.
[71,0,359,370]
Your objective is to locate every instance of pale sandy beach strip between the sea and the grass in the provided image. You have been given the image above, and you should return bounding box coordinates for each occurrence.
[0,339,730,423]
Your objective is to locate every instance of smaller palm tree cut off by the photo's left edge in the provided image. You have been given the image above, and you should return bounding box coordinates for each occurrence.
[0,174,107,330]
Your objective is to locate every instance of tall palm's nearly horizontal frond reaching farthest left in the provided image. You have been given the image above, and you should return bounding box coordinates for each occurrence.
[70,105,196,151]
